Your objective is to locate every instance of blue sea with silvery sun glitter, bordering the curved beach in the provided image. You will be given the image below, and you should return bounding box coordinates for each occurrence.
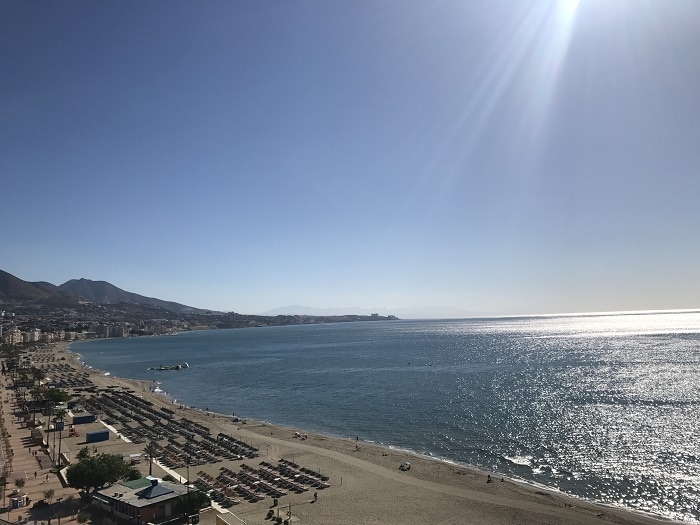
[72,312,700,522]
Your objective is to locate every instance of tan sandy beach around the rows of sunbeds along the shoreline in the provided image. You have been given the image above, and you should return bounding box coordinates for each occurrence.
[2,343,671,525]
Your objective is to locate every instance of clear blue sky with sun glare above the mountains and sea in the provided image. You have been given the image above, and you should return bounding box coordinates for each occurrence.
[0,0,700,315]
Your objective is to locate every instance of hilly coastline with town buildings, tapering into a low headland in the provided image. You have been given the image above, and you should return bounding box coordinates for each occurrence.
[0,270,398,342]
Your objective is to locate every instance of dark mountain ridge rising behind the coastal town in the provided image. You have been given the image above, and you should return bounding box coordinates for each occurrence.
[0,270,204,313]
